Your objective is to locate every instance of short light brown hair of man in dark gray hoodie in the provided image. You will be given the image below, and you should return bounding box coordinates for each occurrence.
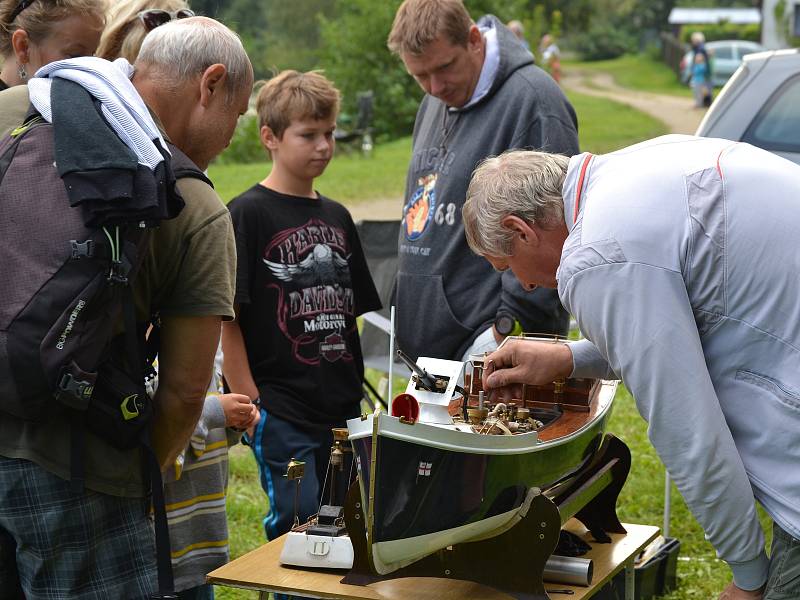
[386,0,473,56]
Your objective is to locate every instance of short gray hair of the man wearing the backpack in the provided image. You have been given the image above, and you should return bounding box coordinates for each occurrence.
[136,17,253,102]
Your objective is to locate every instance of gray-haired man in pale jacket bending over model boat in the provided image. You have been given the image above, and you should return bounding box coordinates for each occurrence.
[463,135,800,600]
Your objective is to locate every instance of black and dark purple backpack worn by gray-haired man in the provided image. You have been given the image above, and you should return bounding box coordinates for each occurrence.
[0,104,210,597]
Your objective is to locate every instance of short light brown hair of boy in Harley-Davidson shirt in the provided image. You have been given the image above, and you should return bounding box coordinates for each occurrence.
[256,70,339,139]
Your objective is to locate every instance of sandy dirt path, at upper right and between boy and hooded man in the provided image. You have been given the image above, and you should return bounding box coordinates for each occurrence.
[348,71,703,221]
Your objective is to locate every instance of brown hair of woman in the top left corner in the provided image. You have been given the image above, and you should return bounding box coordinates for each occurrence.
[0,0,108,57]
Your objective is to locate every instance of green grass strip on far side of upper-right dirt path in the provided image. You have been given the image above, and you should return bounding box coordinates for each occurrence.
[563,54,692,98]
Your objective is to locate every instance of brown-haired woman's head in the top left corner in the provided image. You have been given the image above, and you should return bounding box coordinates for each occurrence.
[0,0,106,90]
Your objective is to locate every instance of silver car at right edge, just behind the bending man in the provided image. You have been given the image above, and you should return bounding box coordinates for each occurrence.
[697,49,800,164]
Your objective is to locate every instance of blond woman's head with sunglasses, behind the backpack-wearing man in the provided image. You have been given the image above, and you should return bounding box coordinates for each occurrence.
[97,0,194,63]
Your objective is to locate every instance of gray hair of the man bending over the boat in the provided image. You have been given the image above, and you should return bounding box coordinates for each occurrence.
[461,150,569,257]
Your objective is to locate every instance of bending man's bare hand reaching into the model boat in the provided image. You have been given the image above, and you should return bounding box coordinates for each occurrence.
[483,339,573,400]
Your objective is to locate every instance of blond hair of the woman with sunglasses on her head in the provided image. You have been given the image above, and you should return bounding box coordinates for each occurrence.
[95,0,189,64]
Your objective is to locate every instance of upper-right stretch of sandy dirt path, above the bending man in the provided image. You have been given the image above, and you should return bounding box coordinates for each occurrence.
[561,71,704,134]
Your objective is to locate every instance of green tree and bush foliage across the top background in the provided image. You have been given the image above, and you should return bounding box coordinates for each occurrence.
[198,0,759,137]
